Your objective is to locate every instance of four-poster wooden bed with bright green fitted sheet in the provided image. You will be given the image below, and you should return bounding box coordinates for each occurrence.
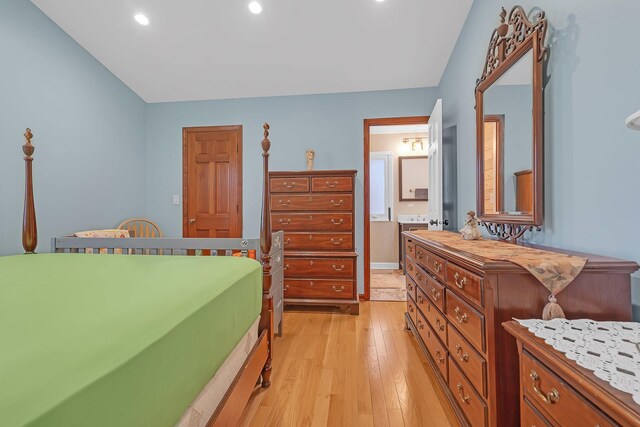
[0,124,281,426]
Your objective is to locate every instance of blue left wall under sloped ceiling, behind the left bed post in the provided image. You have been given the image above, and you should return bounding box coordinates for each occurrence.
[0,0,146,255]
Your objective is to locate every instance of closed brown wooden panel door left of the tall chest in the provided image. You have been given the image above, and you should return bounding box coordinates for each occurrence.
[182,126,242,238]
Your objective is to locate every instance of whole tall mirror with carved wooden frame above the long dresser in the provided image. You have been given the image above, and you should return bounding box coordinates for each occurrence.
[476,6,547,240]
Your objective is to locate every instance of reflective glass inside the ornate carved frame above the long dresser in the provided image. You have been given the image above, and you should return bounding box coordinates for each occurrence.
[483,50,534,215]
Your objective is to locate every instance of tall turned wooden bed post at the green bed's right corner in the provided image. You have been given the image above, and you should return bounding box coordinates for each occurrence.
[260,123,274,388]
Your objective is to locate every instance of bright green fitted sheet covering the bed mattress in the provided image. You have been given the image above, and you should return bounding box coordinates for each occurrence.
[0,254,262,427]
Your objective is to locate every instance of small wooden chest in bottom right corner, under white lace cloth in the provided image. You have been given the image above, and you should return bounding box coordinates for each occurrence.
[504,320,640,427]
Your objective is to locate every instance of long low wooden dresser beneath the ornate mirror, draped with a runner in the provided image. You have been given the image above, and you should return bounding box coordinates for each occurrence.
[403,232,638,427]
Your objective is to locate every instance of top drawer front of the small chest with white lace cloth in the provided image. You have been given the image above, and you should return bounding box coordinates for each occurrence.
[520,351,614,427]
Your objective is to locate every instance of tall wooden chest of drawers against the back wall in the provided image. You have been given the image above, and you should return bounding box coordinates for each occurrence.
[269,170,359,314]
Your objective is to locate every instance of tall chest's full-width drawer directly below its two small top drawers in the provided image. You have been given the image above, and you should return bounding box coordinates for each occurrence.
[271,194,353,211]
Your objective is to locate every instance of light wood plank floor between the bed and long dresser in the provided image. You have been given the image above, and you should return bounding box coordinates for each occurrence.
[241,302,455,427]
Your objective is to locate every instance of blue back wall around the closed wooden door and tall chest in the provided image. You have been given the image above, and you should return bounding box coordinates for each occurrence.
[147,88,438,292]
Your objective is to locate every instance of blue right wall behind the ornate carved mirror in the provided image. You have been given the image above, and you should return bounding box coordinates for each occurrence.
[440,0,640,319]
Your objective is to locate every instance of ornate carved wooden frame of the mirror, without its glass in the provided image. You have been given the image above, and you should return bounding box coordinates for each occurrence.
[475,6,547,242]
